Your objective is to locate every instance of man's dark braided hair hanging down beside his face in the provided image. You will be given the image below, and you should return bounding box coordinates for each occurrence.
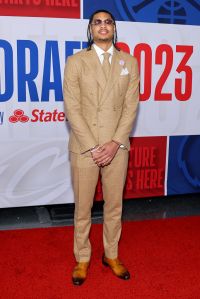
[87,9,119,51]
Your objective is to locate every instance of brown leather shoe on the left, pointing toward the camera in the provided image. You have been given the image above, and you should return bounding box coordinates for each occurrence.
[72,262,89,286]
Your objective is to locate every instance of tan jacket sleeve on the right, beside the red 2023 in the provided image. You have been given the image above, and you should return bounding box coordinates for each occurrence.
[113,57,139,145]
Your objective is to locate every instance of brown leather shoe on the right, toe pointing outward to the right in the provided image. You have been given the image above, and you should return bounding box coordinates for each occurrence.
[102,255,130,280]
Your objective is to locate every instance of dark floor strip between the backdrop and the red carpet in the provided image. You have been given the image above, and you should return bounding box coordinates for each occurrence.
[0,193,200,230]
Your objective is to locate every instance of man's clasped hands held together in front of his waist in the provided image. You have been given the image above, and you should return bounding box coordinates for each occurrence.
[92,141,119,167]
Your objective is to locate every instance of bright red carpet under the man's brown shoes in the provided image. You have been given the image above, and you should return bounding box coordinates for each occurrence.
[0,217,200,299]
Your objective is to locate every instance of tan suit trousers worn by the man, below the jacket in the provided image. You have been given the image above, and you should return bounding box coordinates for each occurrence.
[70,149,128,262]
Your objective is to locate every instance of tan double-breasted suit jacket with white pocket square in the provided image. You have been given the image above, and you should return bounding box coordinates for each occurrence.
[64,48,139,153]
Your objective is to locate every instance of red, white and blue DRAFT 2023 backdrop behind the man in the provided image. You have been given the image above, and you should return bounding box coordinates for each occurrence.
[0,0,200,207]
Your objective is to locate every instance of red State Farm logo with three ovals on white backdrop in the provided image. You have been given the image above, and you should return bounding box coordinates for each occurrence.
[9,109,67,123]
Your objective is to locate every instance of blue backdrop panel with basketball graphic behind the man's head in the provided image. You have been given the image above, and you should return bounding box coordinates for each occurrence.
[83,0,200,25]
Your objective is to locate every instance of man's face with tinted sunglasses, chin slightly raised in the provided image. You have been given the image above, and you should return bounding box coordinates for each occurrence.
[90,12,115,42]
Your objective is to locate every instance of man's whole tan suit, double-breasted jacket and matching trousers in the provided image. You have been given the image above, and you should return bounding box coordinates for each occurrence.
[64,48,139,262]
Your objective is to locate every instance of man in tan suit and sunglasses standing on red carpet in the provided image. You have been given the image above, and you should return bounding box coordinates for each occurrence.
[64,10,139,285]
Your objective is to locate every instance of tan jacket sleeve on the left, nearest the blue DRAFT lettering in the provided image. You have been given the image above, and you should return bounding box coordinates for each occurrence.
[63,56,98,153]
